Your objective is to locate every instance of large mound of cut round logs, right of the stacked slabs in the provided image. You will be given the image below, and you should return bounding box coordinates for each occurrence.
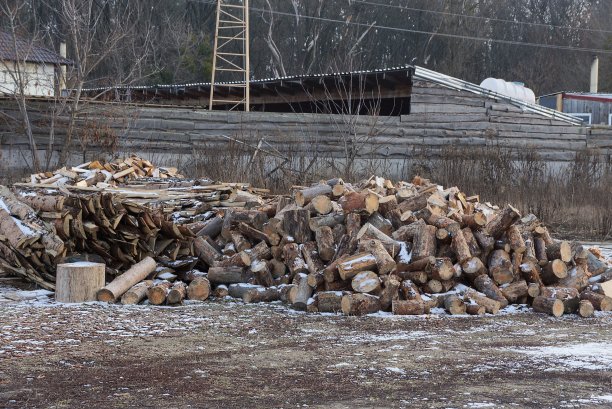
[93,174,612,316]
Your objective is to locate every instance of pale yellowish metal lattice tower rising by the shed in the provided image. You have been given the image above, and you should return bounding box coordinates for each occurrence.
[209,0,250,111]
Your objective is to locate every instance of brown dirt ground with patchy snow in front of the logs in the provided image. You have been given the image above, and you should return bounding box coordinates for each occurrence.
[0,286,612,408]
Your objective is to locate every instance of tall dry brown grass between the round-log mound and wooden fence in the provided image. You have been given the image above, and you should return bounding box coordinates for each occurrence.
[188,142,612,240]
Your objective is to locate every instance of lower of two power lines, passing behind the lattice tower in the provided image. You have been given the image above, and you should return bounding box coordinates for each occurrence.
[192,0,612,54]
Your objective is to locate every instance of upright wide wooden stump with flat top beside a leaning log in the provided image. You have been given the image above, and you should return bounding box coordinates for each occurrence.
[55,261,105,303]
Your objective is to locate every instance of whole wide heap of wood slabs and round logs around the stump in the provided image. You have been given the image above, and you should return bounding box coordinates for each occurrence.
[0,159,612,317]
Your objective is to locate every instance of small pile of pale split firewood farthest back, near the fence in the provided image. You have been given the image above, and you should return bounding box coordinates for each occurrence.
[27,155,183,187]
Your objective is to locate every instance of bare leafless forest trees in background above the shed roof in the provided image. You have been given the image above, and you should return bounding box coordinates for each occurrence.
[0,0,612,94]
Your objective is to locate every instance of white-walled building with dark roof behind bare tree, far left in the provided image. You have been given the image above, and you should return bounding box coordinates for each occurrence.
[0,32,72,97]
